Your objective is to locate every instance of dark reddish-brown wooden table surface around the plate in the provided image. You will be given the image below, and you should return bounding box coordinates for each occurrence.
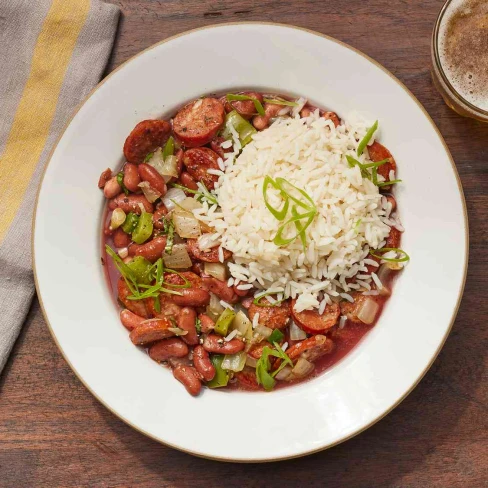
[0,0,488,488]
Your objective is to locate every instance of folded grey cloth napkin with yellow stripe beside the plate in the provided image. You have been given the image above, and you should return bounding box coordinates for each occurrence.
[0,0,119,372]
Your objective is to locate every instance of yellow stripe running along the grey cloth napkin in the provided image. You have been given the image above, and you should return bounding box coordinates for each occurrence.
[0,0,90,243]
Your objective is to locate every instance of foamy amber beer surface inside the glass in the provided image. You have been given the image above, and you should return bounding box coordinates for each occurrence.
[438,0,488,110]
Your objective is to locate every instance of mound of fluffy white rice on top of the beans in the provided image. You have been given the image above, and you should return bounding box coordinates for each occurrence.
[196,112,401,311]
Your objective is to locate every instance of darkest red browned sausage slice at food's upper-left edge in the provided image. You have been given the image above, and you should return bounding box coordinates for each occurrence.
[124,120,171,164]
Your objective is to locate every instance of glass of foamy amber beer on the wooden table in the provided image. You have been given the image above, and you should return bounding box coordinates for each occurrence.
[432,0,488,122]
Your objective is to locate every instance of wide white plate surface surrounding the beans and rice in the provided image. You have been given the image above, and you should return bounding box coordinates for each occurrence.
[33,23,468,461]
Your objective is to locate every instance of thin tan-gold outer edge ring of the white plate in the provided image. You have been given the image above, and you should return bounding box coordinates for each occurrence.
[31,21,469,464]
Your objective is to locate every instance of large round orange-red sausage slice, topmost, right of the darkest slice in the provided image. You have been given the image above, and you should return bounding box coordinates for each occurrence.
[173,98,225,147]
